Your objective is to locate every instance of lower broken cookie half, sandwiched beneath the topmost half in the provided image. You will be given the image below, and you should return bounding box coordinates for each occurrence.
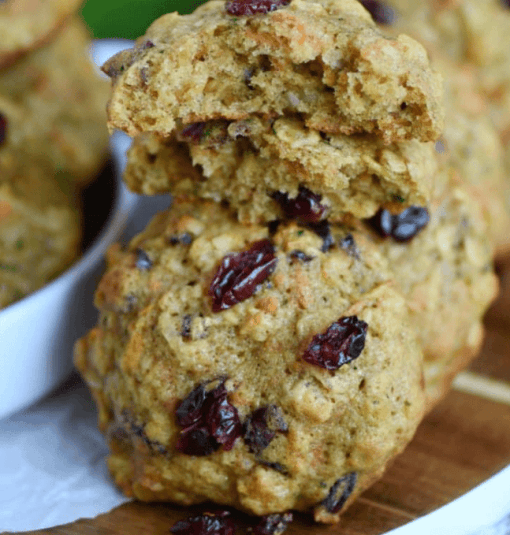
[124,117,437,223]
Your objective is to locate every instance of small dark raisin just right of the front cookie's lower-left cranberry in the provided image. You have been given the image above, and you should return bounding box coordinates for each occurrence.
[244,405,288,455]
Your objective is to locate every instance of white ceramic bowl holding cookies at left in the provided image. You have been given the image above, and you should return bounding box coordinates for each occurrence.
[0,41,137,418]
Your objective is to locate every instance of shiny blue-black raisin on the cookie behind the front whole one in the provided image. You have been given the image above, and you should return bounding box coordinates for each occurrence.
[368,206,430,242]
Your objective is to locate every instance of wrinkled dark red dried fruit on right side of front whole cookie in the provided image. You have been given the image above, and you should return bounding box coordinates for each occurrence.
[303,316,368,370]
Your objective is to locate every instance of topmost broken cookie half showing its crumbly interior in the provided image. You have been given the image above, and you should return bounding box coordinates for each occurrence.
[103,0,443,143]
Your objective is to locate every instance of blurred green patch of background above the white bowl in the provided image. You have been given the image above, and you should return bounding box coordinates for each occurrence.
[83,0,202,39]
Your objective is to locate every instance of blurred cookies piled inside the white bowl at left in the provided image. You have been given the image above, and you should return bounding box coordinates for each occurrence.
[0,0,108,308]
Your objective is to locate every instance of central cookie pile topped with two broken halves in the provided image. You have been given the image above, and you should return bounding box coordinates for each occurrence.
[75,0,500,522]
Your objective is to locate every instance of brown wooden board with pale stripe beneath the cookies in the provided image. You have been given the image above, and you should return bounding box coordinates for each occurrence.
[15,262,510,535]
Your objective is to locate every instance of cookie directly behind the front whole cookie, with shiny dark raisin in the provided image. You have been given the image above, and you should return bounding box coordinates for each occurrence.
[365,170,498,408]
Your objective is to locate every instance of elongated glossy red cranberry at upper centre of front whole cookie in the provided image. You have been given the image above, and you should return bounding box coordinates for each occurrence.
[209,240,278,312]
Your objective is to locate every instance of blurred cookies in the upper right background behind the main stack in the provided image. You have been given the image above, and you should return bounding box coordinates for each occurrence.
[365,0,510,256]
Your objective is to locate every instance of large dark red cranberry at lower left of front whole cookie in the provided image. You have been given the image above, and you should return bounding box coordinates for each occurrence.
[175,379,242,456]
